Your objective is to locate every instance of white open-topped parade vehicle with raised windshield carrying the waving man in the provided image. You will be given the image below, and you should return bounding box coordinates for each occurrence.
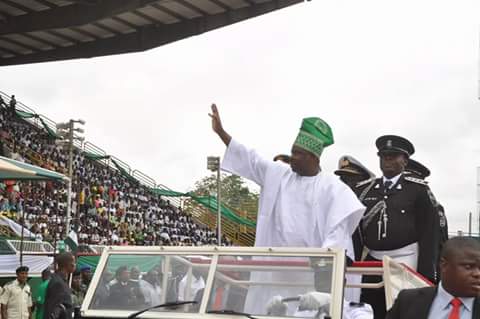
[80,246,429,319]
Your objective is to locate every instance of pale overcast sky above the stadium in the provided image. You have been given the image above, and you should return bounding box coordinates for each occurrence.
[0,0,480,231]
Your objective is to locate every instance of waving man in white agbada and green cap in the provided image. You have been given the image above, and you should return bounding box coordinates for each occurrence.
[210,105,364,314]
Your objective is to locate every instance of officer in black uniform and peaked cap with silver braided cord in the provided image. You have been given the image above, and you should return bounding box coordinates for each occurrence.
[357,135,439,319]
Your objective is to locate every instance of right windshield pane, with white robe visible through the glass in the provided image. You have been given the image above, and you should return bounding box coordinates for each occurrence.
[207,256,334,316]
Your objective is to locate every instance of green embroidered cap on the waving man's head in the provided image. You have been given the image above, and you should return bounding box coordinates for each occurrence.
[293,117,333,157]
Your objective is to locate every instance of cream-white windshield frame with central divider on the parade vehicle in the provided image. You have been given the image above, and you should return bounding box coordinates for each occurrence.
[80,246,345,319]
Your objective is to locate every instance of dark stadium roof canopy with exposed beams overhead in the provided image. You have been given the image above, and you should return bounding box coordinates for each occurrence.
[0,0,304,66]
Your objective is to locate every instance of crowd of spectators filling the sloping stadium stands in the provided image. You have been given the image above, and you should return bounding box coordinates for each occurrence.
[0,102,229,246]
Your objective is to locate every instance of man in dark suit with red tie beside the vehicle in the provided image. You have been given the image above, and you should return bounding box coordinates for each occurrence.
[386,237,480,319]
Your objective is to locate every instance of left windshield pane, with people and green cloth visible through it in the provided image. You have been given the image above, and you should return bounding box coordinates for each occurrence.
[89,253,212,312]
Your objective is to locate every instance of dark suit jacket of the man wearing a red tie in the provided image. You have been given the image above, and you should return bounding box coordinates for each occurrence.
[385,287,480,319]
